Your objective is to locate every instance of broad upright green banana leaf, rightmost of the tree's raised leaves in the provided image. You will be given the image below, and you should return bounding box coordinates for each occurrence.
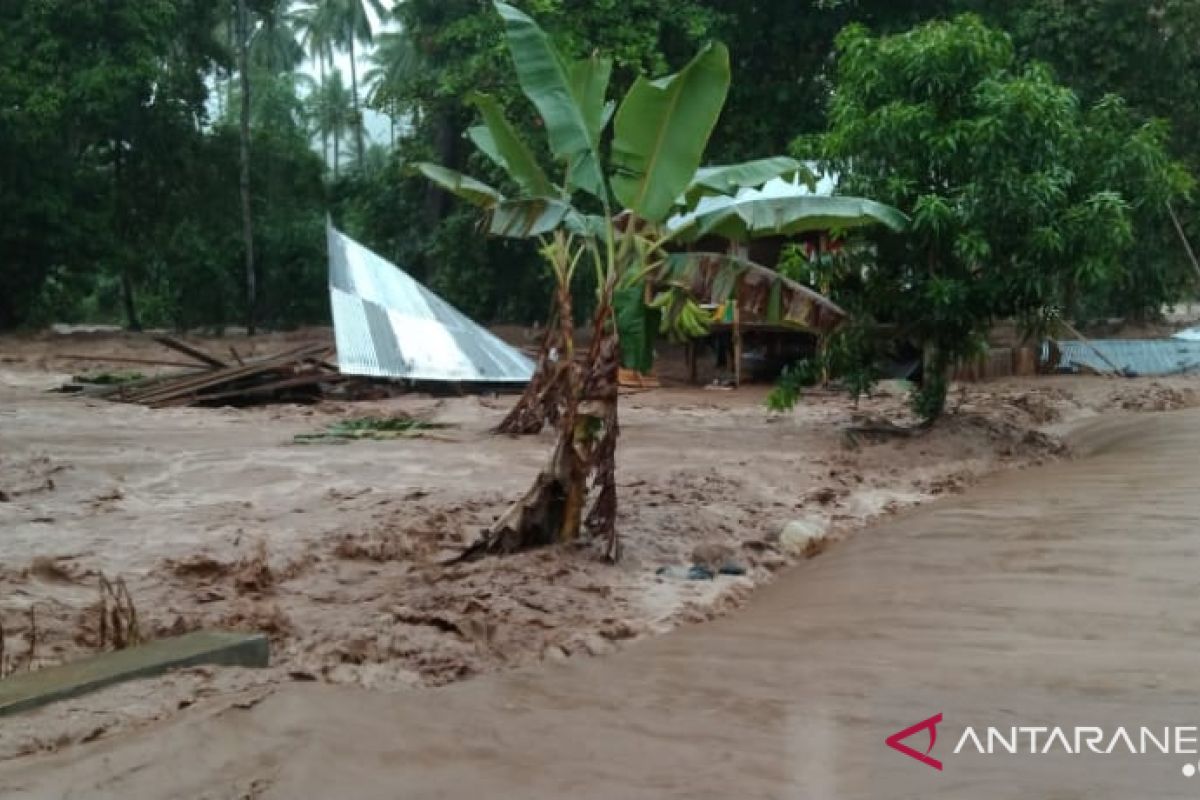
[611,44,730,222]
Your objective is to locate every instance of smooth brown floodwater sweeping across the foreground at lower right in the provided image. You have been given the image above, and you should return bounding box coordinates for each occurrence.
[0,410,1200,800]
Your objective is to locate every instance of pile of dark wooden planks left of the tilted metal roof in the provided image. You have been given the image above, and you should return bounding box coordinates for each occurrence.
[67,336,349,408]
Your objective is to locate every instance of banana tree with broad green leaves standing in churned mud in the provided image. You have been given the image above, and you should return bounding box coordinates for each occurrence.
[419,2,902,559]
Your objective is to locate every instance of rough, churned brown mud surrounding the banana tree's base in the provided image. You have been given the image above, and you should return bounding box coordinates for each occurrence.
[0,333,1200,758]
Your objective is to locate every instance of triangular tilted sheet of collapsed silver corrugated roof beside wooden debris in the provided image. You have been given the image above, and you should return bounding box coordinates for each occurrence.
[326,225,534,383]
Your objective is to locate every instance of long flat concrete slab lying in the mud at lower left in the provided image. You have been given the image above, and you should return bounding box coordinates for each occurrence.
[0,631,270,717]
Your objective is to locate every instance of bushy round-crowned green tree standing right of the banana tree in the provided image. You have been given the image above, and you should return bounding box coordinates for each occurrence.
[821,16,1190,416]
